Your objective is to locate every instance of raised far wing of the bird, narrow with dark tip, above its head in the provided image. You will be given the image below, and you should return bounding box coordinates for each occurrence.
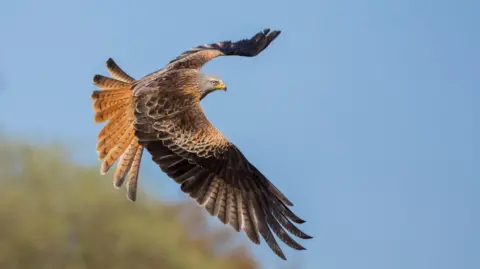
[166,28,280,70]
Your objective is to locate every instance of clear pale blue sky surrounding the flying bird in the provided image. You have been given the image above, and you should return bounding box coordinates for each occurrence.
[0,0,480,269]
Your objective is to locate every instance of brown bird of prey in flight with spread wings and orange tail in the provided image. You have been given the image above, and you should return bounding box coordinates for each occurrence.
[91,28,312,260]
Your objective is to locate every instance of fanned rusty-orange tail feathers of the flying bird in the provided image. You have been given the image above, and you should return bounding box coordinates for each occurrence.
[91,58,143,201]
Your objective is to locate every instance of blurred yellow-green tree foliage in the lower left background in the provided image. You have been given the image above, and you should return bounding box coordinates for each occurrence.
[0,138,258,269]
